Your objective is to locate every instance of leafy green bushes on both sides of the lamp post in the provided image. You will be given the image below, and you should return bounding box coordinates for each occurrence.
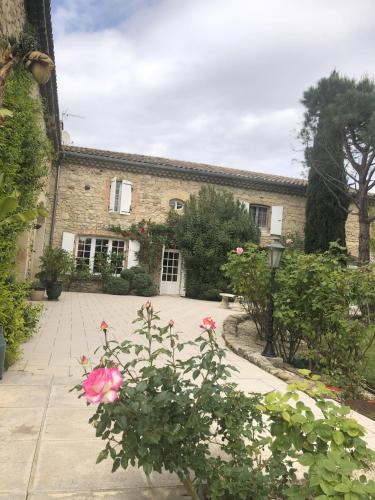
[223,245,375,397]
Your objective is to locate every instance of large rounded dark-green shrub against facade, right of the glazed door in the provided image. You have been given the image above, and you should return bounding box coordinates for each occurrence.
[169,187,259,298]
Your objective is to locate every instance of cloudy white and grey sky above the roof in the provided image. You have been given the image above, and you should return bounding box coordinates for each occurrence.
[52,0,375,180]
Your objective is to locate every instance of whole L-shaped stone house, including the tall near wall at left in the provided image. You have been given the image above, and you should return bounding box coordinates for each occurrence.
[0,0,364,294]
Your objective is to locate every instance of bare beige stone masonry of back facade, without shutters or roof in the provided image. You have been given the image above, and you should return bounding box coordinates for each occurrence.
[53,162,305,252]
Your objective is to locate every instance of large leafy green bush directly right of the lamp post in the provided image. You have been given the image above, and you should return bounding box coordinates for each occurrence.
[274,246,375,396]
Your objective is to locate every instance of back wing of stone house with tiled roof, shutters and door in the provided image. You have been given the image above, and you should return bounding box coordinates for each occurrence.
[51,146,358,294]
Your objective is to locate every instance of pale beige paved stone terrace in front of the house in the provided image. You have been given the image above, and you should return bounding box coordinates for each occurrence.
[0,292,375,500]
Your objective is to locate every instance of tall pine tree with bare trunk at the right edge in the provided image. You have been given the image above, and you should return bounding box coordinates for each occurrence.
[301,72,375,262]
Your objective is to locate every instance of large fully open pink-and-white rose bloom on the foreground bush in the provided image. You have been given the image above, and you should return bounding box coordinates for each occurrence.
[82,367,123,403]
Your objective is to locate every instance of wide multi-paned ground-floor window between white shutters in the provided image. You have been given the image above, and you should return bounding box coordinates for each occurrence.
[76,236,125,275]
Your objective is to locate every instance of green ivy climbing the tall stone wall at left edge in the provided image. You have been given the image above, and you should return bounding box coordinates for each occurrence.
[0,65,51,365]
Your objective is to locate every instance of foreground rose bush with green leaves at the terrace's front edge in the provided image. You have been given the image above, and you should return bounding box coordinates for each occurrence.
[75,302,374,500]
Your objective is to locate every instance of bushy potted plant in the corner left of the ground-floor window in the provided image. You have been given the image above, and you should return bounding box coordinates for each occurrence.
[36,247,73,300]
